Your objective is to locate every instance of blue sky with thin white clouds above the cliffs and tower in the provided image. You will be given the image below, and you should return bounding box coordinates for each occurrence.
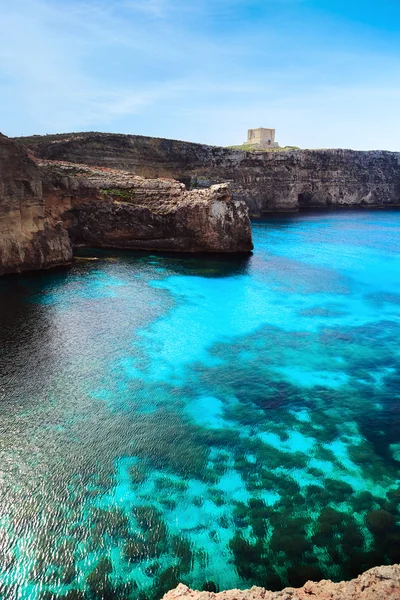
[0,0,400,151]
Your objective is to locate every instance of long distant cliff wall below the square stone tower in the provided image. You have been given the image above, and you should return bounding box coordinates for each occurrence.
[16,133,400,215]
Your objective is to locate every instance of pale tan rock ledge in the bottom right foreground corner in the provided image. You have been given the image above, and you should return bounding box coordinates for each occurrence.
[163,565,400,600]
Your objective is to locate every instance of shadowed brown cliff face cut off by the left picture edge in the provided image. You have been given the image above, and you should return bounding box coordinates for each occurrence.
[0,134,72,275]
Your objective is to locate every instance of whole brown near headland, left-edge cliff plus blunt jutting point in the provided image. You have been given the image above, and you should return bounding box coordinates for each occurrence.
[0,136,253,275]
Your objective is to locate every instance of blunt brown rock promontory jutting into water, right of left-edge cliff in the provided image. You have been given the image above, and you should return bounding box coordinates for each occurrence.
[39,161,253,252]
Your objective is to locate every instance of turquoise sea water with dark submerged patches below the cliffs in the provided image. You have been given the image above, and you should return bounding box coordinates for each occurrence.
[0,211,400,600]
